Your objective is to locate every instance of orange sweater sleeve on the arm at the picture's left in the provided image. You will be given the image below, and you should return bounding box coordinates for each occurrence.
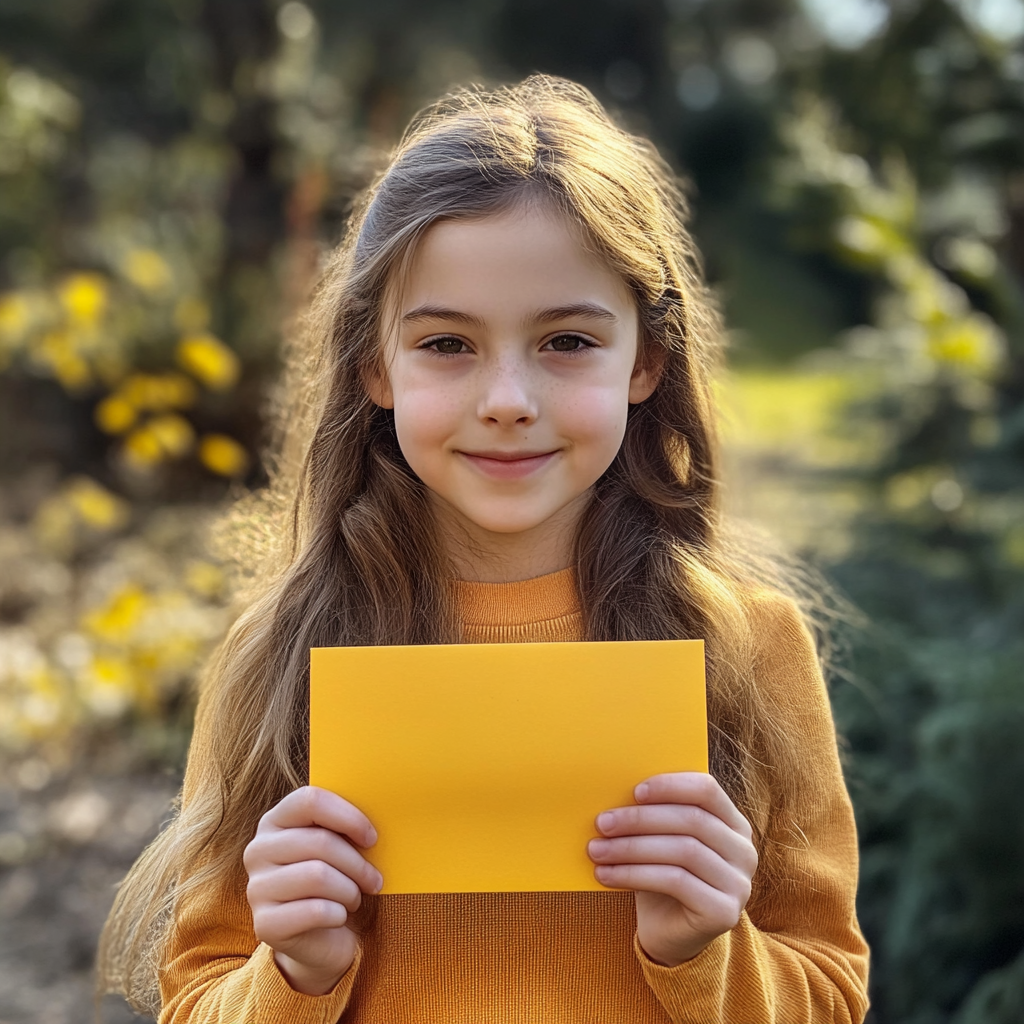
[158,675,361,1024]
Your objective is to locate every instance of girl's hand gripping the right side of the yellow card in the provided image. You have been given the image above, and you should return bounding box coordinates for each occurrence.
[587,772,758,967]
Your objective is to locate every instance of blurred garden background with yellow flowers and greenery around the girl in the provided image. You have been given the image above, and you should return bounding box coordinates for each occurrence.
[0,0,1024,1024]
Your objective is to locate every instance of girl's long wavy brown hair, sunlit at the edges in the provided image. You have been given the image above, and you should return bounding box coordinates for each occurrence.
[98,76,823,1012]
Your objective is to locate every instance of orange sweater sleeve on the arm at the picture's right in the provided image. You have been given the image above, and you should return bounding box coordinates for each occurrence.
[634,596,868,1024]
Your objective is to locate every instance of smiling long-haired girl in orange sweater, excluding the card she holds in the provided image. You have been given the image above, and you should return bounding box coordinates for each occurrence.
[100,77,867,1024]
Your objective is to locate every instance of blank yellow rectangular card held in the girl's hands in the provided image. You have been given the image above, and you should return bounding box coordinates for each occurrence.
[309,640,708,893]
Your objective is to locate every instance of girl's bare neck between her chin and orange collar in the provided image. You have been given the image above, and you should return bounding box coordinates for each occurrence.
[432,493,590,583]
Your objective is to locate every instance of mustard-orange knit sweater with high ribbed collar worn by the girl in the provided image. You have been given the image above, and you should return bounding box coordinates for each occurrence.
[159,569,867,1024]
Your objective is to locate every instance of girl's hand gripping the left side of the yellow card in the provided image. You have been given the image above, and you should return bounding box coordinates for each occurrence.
[242,785,384,995]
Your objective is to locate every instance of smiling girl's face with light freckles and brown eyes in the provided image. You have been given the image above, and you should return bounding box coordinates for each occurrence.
[370,205,656,565]
